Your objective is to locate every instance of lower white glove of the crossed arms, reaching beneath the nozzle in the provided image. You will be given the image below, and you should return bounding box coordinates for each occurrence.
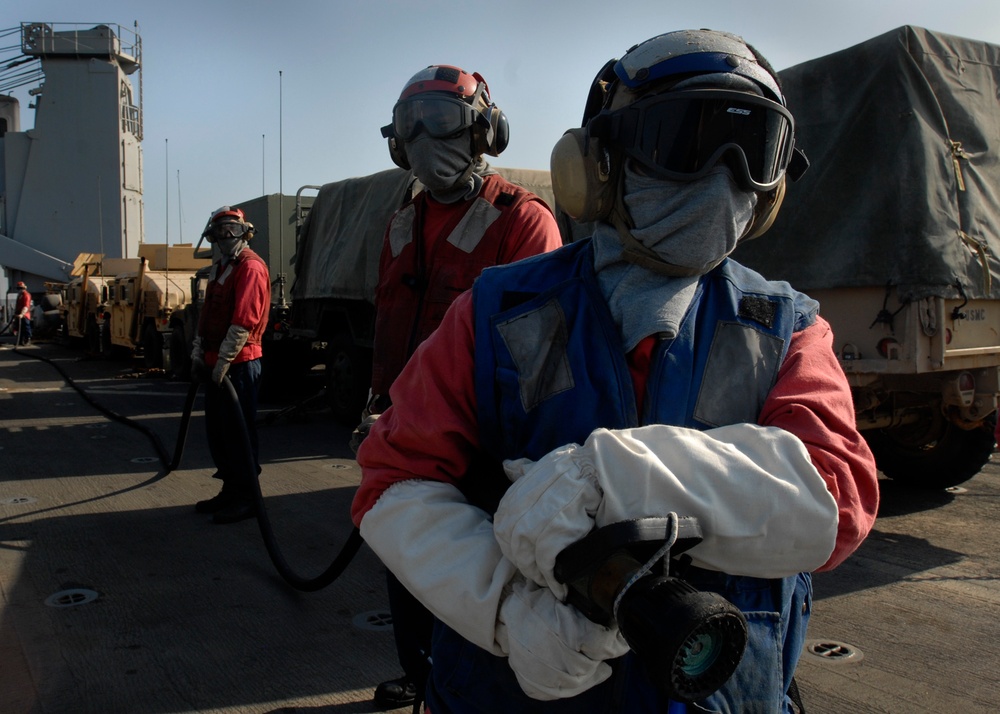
[361,479,628,699]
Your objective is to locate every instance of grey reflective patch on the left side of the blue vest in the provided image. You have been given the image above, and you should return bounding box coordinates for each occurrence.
[497,299,573,412]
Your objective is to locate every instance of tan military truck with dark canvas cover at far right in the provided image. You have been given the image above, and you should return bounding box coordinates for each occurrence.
[733,26,1000,488]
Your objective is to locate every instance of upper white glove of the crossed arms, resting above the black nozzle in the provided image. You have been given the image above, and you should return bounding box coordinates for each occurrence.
[494,424,838,598]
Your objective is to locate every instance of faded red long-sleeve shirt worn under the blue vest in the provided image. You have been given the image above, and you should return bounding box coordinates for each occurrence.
[352,292,878,570]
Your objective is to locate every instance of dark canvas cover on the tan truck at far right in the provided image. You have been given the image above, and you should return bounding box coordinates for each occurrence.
[733,26,1000,302]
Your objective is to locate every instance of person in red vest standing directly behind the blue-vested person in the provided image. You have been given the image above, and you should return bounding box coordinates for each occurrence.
[360,65,562,708]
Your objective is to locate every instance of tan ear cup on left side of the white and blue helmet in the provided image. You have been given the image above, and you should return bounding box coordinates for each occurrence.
[549,129,620,218]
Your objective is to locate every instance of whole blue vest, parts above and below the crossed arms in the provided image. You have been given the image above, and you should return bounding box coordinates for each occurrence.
[427,241,818,714]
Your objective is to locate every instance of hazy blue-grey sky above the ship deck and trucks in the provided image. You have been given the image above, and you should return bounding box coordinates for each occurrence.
[0,0,1000,243]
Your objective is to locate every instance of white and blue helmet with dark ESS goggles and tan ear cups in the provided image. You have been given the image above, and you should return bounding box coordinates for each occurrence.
[551,30,808,238]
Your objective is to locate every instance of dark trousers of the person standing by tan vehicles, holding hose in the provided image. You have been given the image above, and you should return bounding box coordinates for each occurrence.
[205,359,260,495]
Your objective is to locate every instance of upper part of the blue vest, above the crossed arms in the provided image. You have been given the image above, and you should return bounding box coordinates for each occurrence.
[473,234,818,459]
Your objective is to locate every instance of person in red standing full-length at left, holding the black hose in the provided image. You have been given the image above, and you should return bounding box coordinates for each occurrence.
[191,206,271,523]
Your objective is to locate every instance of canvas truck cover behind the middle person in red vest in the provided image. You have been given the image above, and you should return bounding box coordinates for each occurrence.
[291,168,568,304]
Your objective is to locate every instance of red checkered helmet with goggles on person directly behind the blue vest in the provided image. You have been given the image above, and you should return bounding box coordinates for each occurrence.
[382,64,510,169]
